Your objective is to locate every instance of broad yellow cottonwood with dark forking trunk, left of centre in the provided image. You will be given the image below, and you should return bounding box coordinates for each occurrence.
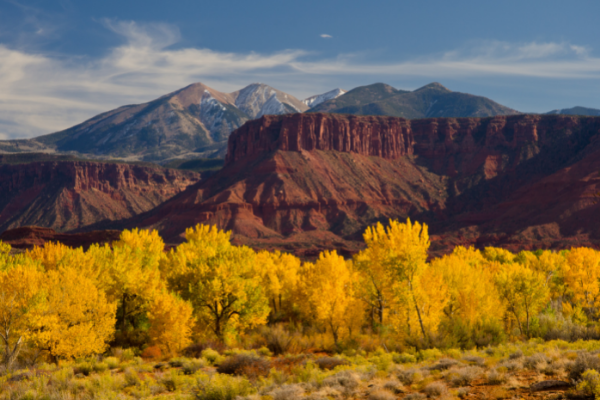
[162,225,269,340]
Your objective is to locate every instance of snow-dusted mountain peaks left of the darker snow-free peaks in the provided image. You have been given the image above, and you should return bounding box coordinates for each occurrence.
[0,83,308,162]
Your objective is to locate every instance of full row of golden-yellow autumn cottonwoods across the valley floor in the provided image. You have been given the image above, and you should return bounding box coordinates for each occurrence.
[0,220,600,369]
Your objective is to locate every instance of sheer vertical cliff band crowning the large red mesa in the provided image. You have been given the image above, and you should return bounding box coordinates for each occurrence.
[225,113,579,166]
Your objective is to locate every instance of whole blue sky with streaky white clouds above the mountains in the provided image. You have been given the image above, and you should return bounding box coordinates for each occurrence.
[0,0,600,139]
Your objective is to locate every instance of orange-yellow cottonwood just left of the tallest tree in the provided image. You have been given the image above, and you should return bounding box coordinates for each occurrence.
[301,251,362,345]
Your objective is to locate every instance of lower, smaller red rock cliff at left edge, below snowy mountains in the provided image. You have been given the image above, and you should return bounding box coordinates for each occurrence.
[0,161,201,232]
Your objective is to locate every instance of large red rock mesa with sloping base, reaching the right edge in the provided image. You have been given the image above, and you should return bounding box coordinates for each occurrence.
[113,114,600,255]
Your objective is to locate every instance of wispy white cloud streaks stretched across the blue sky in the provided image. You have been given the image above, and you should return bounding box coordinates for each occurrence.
[0,20,600,138]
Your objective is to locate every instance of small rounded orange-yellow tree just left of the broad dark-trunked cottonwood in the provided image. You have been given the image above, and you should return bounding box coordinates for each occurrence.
[148,291,194,356]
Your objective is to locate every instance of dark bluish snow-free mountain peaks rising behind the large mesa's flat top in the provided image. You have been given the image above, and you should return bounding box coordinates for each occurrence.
[309,83,518,119]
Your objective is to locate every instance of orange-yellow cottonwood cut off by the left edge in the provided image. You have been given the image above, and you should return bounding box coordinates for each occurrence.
[0,257,44,370]
